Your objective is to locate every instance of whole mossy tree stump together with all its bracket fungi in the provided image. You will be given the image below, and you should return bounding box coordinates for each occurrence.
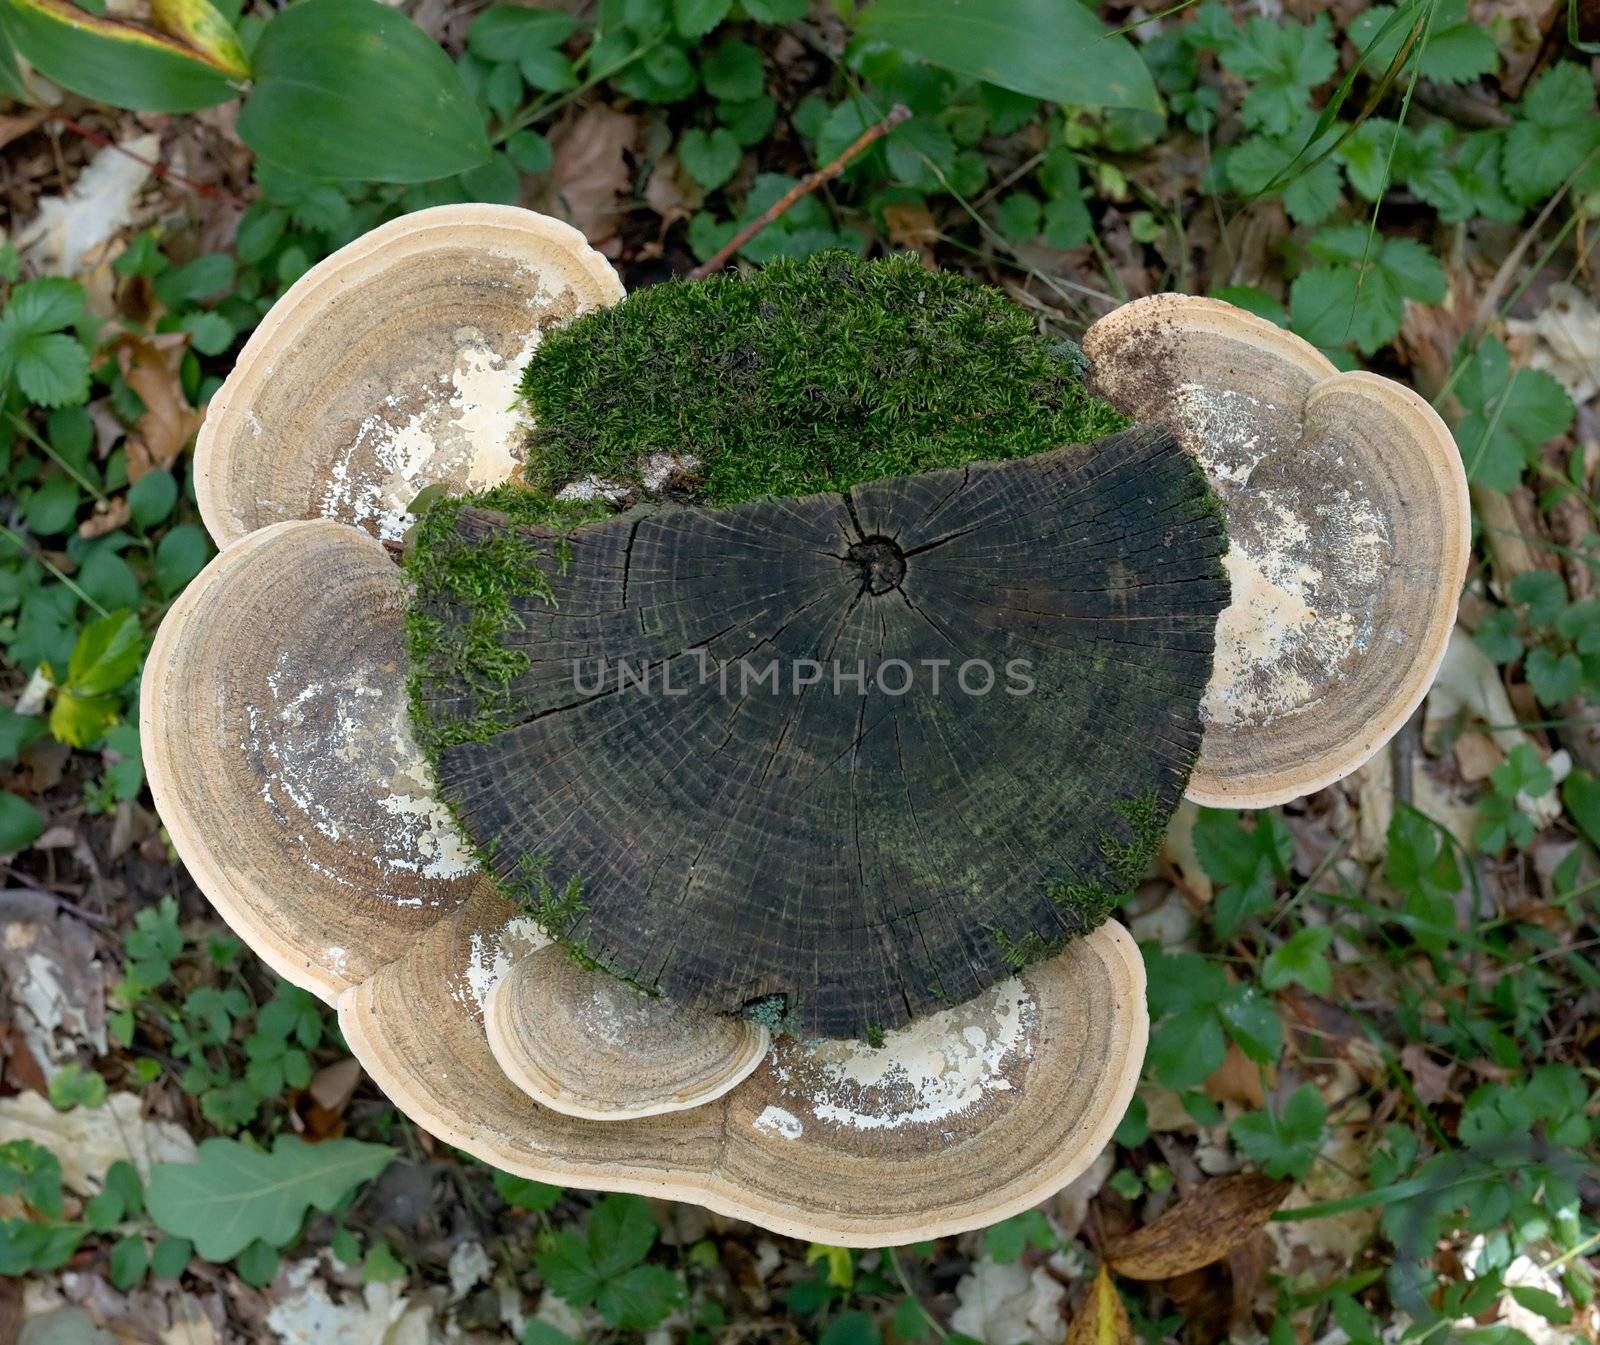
[141,206,1464,1246]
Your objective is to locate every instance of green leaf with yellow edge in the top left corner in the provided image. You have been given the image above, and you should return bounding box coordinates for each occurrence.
[0,0,238,112]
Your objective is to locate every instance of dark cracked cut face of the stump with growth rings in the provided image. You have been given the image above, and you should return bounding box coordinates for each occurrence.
[409,429,1227,1036]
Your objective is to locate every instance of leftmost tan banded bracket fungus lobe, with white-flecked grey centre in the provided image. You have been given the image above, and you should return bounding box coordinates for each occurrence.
[139,521,485,1001]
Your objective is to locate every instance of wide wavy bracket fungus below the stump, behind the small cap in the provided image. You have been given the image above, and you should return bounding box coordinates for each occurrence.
[339,897,1147,1247]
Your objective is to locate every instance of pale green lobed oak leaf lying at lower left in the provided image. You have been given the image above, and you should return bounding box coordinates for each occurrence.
[146,1135,395,1262]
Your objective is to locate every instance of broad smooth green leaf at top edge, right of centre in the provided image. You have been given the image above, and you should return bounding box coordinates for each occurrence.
[858,0,1162,114]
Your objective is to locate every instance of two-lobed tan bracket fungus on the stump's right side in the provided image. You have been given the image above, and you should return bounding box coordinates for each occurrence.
[1083,294,1470,808]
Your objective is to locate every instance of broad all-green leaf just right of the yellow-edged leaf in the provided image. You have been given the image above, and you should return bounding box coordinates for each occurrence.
[238,0,490,182]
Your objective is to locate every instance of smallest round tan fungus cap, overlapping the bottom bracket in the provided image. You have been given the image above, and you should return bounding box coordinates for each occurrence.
[483,947,771,1121]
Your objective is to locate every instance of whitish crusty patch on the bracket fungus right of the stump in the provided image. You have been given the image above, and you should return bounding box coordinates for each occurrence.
[1174,384,1392,724]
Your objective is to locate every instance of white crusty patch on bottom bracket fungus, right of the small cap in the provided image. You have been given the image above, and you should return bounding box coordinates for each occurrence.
[755,977,1038,1131]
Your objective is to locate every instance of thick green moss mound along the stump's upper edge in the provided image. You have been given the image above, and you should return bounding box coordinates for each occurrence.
[522,253,1128,505]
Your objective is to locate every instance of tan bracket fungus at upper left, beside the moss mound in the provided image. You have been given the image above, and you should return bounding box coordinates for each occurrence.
[195,205,622,547]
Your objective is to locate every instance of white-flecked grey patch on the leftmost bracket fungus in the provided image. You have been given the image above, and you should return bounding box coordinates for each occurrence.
[240,651,474,901]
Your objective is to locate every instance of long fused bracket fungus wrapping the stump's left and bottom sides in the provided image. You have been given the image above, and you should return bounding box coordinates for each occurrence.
[141,521,1147,1246]
